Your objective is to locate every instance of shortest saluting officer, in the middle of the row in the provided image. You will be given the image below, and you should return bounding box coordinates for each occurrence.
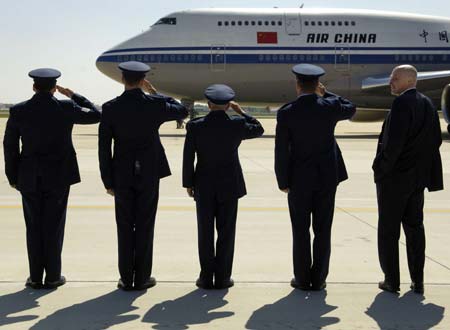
[183,84,264,289]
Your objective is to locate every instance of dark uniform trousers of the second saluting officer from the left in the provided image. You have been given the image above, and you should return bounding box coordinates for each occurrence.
[114,182,159,285]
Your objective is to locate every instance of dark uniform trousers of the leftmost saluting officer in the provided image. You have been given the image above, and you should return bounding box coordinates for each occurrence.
[21,182,70,283]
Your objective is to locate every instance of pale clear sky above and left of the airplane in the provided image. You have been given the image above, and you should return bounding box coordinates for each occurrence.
[0,0,450,104]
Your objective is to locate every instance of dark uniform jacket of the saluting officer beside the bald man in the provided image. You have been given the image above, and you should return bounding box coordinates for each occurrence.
[275,93,356,193]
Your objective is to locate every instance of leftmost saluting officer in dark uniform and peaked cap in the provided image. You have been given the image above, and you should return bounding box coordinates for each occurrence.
[3,69,100,289]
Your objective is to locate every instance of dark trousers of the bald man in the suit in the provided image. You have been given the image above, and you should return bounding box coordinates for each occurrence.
[377,181,425,286]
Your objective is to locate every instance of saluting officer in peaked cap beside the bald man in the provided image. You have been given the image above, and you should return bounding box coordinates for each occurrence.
[275,64,355,290]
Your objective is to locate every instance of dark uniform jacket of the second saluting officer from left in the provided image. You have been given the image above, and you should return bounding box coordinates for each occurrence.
[98,88,188,189]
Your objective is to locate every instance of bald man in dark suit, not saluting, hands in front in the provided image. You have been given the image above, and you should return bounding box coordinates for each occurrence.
[373,65,443,294]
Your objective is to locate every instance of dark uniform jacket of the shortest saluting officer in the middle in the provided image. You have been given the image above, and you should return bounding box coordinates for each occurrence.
[183,111,264,201]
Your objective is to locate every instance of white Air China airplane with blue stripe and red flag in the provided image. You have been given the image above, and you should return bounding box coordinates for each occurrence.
[96,8,450,133]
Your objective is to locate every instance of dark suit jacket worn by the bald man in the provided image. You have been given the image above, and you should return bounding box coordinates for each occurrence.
[373,89,443,191]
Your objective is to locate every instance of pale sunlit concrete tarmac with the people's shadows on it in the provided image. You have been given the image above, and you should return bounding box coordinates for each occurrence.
[0,118,450,330]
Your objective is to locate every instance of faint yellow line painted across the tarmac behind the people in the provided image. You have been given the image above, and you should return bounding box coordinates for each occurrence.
[0,204,450,214]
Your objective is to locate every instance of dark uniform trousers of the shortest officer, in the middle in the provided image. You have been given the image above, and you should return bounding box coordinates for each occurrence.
[196,195,238,283]
